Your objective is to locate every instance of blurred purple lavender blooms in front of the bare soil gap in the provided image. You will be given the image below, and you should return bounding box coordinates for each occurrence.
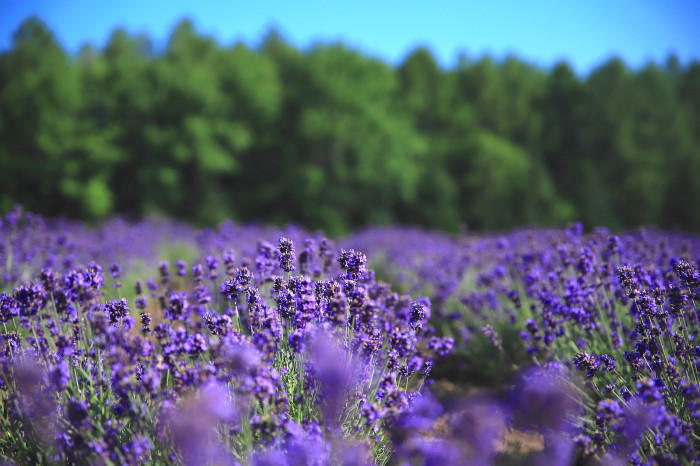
[391,364,579,465]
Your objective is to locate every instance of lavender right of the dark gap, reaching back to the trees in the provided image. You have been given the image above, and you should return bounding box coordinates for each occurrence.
[348,224,700,464]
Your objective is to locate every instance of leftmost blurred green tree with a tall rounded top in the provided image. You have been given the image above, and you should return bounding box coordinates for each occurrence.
[0,17,87,215]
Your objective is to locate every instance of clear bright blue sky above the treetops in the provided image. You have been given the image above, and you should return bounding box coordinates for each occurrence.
[0,0,700,73]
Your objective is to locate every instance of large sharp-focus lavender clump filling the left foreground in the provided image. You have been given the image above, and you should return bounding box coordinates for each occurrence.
[0,210,453,465]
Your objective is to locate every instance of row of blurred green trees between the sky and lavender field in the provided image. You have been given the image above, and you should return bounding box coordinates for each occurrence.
[0,17,700,234]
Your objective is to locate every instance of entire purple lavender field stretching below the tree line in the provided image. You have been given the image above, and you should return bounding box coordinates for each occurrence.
[0,208,700,465]
